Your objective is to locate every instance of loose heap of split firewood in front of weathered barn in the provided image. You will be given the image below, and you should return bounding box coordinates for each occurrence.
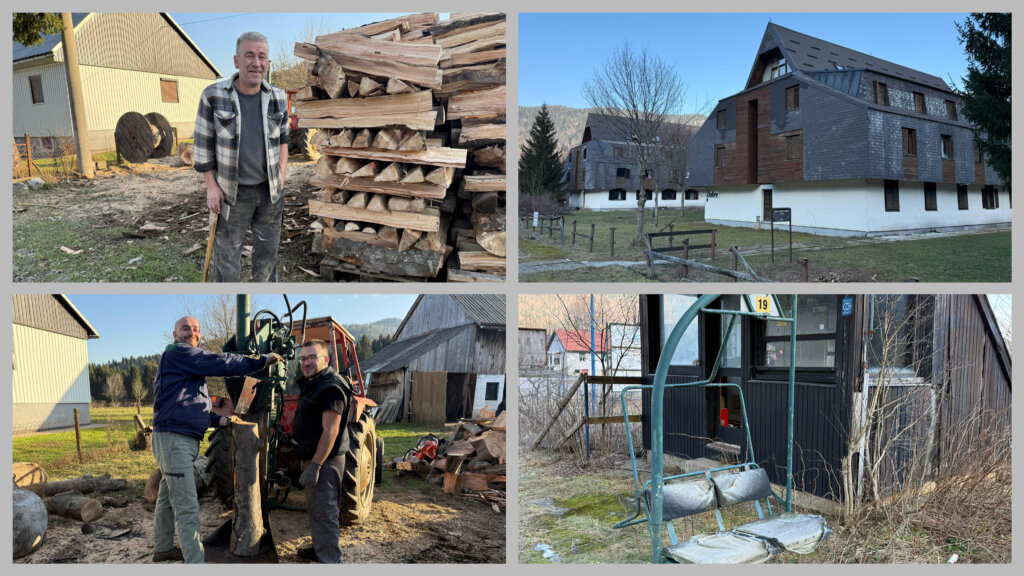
[387,412,506,511]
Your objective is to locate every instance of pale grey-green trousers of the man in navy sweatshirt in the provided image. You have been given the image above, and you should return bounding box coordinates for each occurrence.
[153,431,206,564]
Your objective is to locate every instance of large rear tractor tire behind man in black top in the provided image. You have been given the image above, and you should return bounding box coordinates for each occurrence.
[338,414,378,526]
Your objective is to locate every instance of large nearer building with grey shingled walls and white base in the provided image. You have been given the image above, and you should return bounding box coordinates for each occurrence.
[686,24,1011,236]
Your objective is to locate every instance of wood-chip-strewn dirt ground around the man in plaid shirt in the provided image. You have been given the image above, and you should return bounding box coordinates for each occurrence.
[12,156,321,282]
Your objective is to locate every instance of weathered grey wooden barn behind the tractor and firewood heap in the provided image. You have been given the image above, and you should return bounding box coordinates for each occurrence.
[359,294,506,423]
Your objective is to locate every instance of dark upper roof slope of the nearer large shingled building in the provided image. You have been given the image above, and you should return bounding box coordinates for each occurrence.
[768,23,950,92]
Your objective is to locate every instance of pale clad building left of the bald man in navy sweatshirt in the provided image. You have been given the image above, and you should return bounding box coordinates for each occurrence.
[12,294,99,430]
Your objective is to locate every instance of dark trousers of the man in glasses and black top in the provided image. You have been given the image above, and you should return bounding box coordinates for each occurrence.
[303,454,345,564]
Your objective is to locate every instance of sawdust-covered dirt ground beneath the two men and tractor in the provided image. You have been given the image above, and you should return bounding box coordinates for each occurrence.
[15,470,506,564]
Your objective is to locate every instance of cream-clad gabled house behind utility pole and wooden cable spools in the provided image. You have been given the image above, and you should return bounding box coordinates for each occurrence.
[12,12,222,155]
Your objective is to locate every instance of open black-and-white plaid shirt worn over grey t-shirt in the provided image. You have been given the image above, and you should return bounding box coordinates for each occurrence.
[193,73,289,206]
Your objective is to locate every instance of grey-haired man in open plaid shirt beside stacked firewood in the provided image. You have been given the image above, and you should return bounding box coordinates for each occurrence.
[194,32,288,282]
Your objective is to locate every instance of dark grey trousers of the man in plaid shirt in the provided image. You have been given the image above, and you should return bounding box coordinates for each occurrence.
[213,182,285,282]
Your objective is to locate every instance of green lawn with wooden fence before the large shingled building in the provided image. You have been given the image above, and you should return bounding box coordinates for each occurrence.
[519,209,1011,282]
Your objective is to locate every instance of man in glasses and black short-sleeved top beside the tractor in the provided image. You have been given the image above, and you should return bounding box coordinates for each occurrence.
[293,340,352,564]
